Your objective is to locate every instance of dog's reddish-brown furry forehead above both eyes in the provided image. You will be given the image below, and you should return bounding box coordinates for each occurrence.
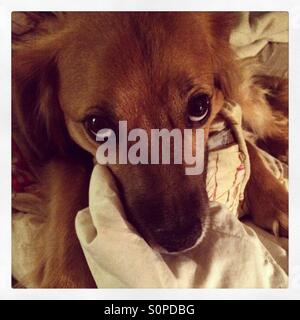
[60,13,211,119]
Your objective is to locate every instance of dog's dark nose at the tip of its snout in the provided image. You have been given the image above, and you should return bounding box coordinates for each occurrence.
[153,219,202,253]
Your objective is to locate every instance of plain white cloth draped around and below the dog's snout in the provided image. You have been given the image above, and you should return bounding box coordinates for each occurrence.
[76,165,288,288]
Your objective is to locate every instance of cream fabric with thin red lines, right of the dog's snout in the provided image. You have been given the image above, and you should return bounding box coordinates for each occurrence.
[206,102,250,216]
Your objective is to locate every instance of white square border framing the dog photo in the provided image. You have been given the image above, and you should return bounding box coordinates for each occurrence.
[0,0,300,300]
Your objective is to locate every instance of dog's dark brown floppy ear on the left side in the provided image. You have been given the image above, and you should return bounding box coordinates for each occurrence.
[12,12,77,162]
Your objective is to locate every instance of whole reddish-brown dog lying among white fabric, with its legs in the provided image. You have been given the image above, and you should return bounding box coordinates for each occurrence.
[12,12,288,288]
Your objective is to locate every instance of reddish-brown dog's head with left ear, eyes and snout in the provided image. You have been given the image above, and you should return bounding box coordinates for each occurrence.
[13,12,238,252]
